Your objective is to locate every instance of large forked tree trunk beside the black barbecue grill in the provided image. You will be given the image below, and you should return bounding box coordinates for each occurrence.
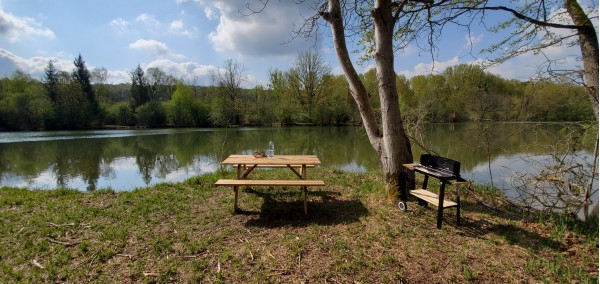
[321,0,414,200]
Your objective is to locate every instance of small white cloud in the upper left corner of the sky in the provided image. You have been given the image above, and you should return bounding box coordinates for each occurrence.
[0,6,54,42]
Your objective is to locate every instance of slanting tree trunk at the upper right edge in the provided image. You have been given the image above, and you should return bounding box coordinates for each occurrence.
[565,0,599,121]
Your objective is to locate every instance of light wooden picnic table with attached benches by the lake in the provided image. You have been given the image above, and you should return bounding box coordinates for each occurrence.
[215,155,325,215]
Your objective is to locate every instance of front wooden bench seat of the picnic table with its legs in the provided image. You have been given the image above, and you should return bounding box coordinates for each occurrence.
[215,179,325,215]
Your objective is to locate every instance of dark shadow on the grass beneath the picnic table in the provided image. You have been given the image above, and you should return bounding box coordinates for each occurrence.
[238,189,369,228]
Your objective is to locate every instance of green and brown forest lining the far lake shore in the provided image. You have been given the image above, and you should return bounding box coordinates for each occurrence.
[0,52,594,131]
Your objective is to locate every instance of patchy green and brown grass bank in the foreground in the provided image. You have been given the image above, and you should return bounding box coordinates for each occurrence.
[0,169,598,283]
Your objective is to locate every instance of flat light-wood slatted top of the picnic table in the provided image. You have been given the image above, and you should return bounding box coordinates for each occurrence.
[221,155,321,165]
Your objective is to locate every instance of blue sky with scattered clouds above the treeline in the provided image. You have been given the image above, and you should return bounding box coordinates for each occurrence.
[0,0,598,87]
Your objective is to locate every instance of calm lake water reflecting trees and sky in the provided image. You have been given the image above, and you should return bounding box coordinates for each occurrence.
[0,123,597,205]
